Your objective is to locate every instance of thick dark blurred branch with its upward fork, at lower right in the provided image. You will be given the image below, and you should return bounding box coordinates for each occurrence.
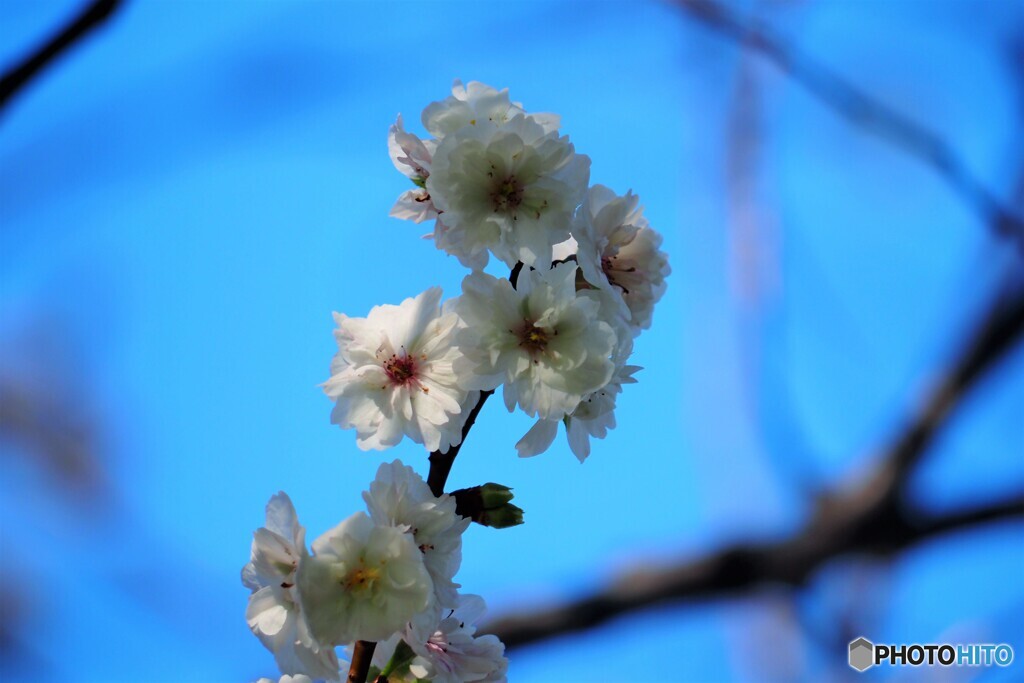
[483,289,1024,647]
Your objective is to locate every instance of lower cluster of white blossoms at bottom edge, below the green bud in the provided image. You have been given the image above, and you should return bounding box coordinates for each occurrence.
[242,461,508,681]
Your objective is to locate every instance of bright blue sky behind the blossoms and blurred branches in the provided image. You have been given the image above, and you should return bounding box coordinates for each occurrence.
[0,0,1024,681]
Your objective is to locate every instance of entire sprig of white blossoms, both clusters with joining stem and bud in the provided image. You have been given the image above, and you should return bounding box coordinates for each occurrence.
[243,81,669,683]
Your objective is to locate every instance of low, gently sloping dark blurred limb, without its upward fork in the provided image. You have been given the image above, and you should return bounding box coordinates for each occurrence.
[483,498,1024,648]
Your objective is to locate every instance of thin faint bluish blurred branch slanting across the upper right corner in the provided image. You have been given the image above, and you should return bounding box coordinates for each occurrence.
[676,0,1024,249]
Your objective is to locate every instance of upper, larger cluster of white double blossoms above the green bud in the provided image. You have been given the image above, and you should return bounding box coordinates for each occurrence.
[376,81,670,460]
